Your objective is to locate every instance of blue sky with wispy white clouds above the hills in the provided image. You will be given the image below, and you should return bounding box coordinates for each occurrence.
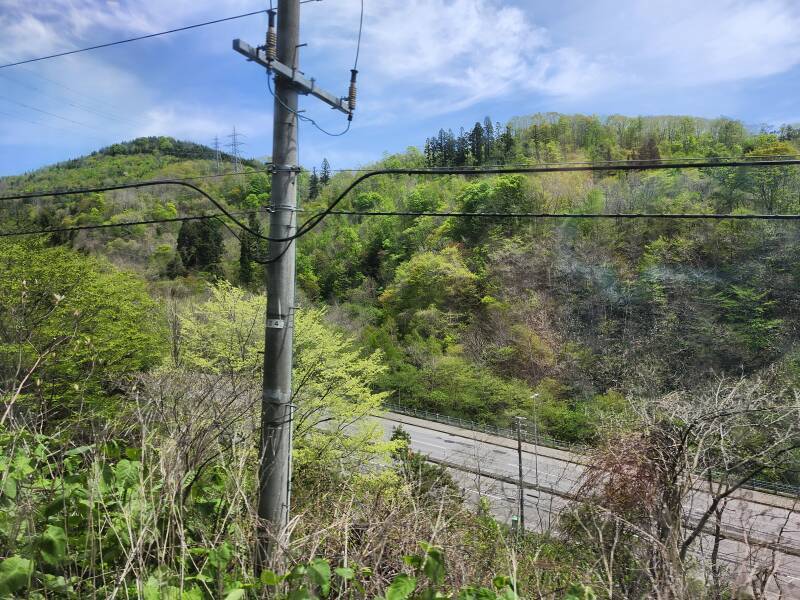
[0,0,800,175]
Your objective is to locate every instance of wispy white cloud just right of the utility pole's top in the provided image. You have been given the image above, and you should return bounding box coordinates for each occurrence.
[309,0,614,115]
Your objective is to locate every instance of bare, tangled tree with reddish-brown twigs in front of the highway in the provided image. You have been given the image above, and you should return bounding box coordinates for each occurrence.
[564,379,800,598]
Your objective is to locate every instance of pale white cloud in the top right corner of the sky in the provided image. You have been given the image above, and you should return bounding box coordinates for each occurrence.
[567,0,800,91]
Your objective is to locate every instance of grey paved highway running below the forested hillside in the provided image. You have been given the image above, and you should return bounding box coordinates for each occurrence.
[380,413,800,598]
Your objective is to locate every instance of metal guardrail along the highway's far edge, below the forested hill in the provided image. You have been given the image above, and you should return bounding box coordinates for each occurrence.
[383,402,800,496]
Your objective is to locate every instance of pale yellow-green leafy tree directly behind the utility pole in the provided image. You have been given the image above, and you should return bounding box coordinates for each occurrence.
[176,282,390,468]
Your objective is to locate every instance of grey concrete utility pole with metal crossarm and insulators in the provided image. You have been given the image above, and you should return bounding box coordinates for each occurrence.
[233,0,355,568]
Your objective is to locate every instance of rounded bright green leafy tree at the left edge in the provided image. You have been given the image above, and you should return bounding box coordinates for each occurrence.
[0,241,166,425]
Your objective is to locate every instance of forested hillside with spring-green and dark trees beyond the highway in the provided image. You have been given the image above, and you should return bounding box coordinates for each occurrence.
[0,114,800,442]
